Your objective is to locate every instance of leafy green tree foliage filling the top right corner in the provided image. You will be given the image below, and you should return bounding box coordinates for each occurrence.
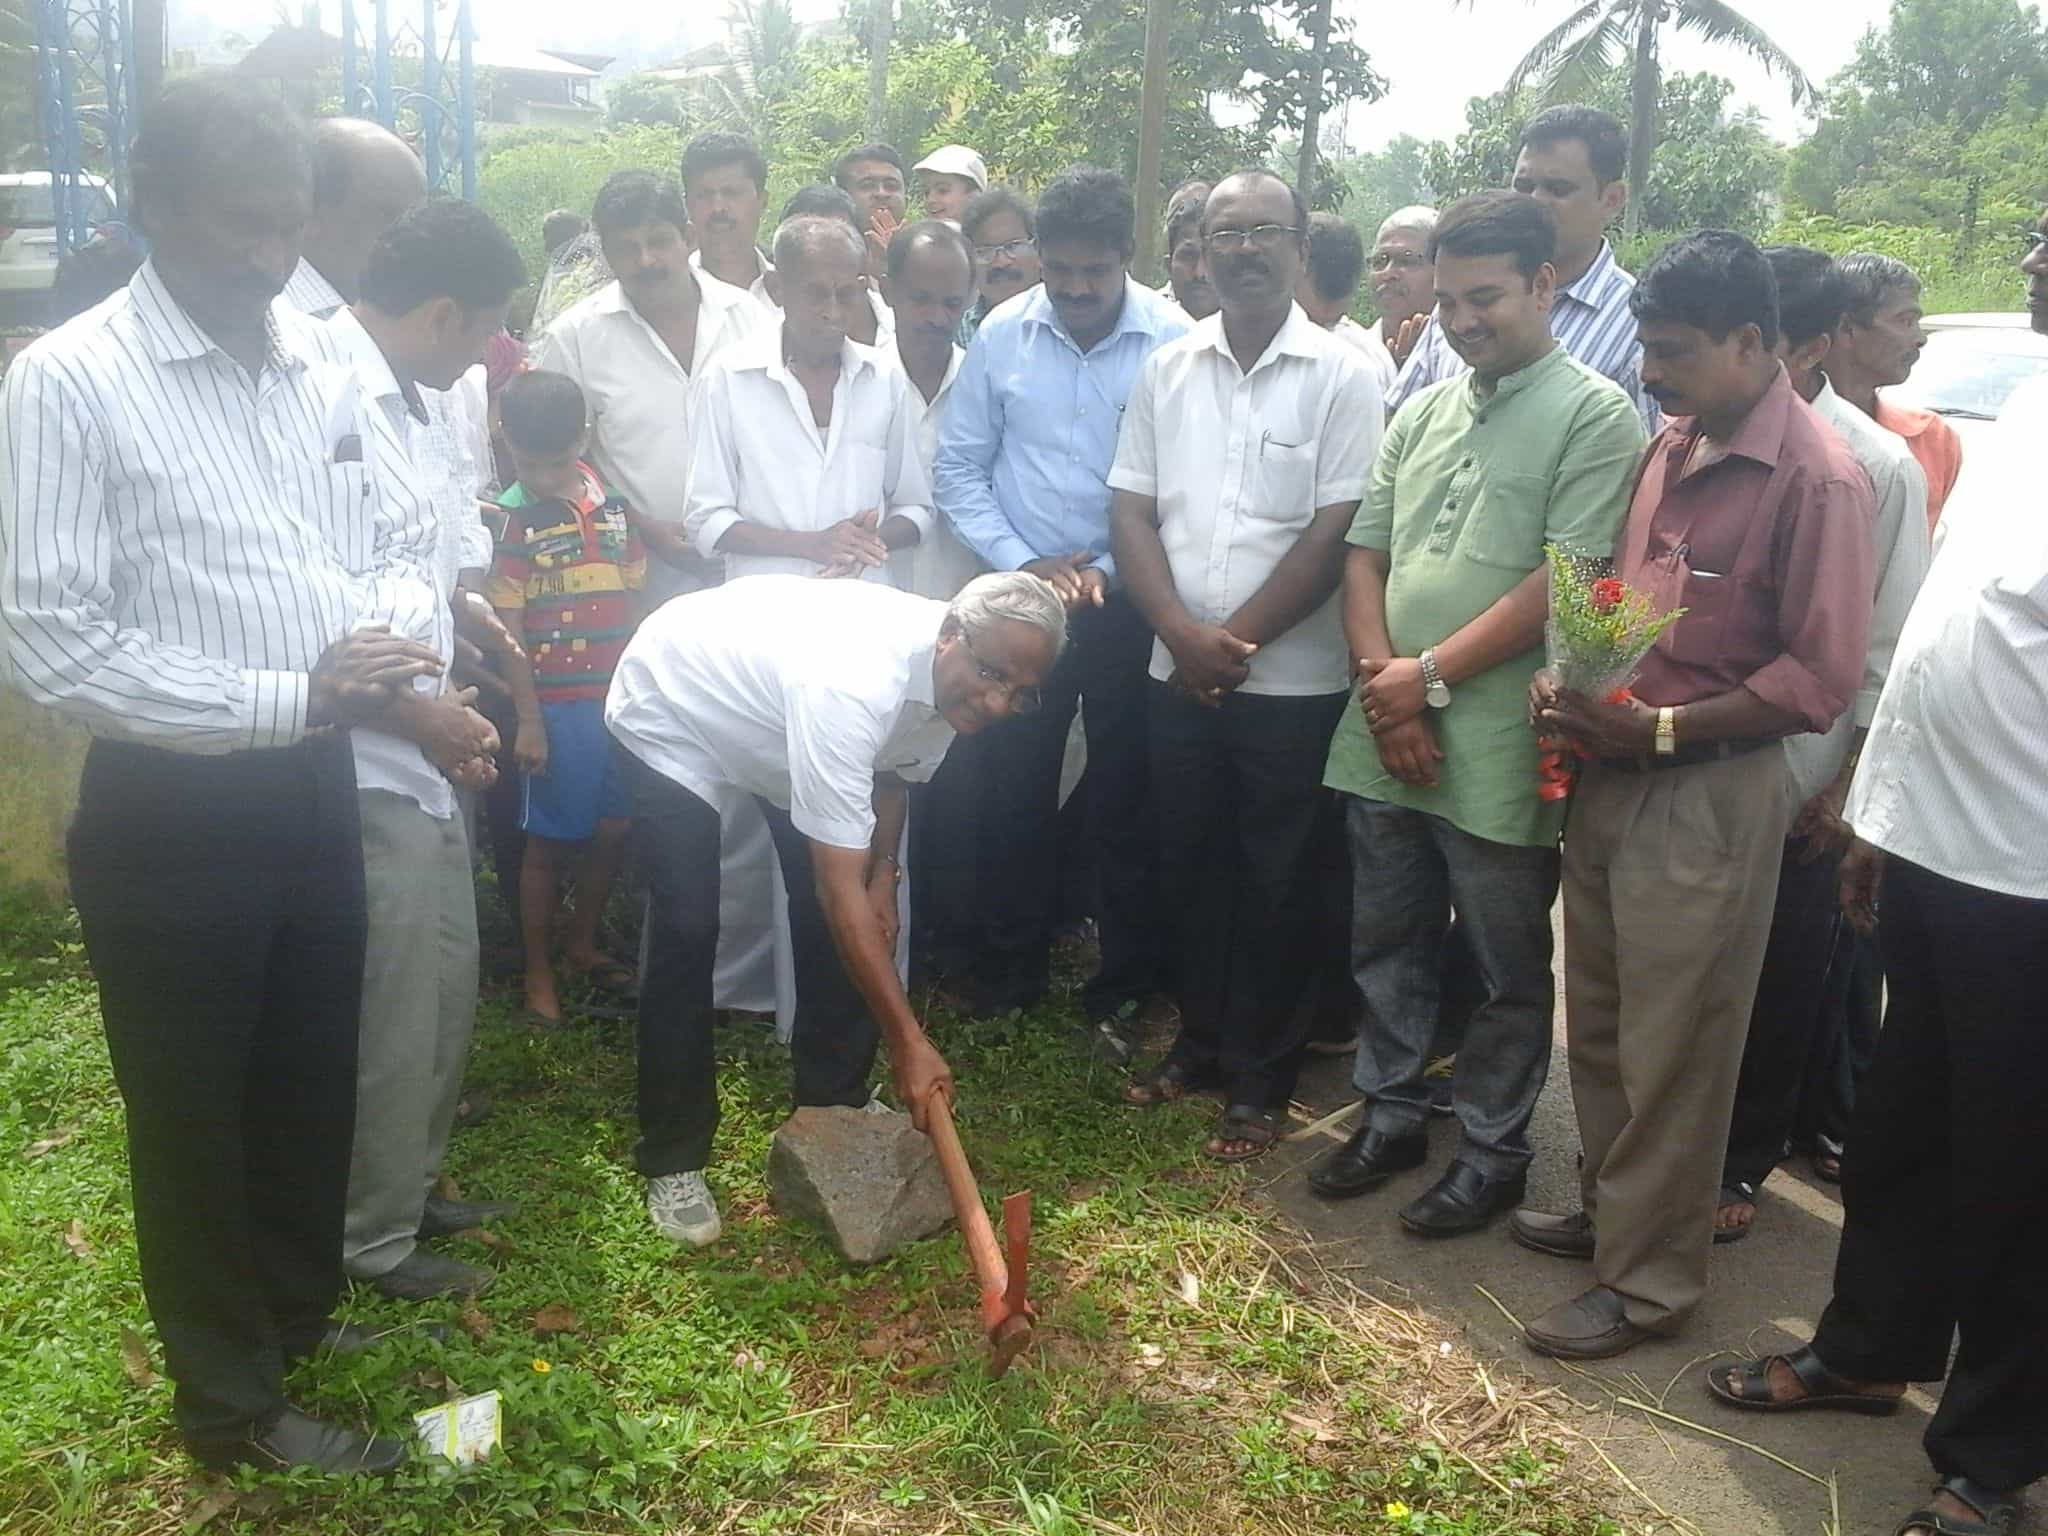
[1784,0,2048,229]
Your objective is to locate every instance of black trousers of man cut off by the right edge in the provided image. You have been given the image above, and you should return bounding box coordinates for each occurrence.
[1812,858,2048,1491]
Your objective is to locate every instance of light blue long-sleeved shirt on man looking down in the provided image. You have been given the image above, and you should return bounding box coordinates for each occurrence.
[932,279,1188,584]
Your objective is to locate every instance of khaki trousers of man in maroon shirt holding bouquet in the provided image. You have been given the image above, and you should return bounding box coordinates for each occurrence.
[1563,745,1798,1333]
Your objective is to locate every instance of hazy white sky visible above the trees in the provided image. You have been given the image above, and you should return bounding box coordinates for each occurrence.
[170,0,1890,150]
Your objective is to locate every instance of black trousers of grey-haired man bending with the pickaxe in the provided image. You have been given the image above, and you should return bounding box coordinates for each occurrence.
[623,754,881,1178]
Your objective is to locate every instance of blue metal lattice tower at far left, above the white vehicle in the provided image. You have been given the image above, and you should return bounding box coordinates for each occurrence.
[33,0,139,252]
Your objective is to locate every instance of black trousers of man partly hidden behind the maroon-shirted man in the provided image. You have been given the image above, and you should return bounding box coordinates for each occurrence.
[1722,838,1843,1186]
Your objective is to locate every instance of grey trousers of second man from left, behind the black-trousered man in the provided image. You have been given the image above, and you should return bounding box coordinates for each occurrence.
[342,788,477,1280]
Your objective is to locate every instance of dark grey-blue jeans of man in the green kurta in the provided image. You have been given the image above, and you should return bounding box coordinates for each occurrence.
[1343,795,1559,1178]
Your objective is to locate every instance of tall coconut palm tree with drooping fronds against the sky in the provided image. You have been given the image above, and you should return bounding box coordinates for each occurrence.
[1456,0,1815,233]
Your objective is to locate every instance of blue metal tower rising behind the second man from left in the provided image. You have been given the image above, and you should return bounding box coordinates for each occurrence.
[340,0,477,201]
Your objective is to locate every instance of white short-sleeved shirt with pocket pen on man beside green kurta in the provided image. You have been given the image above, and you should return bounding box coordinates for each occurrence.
[1110,305,1384,694]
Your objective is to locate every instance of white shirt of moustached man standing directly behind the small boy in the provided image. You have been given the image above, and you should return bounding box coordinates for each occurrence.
[532,281,774,596]
